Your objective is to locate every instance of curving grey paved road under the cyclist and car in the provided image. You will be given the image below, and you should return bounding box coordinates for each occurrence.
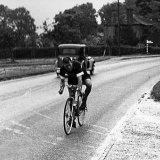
[0,57,160,160]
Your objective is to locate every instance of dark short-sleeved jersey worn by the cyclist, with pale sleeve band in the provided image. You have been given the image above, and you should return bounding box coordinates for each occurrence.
[60,60,90,85]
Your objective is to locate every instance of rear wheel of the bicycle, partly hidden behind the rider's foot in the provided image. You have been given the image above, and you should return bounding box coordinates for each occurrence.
[77,96,86,126]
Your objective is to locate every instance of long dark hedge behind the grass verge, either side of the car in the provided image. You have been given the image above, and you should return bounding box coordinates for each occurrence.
[0,46,160,59]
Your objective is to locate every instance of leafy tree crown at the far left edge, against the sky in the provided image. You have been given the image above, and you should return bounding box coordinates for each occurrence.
[0,5,36,48]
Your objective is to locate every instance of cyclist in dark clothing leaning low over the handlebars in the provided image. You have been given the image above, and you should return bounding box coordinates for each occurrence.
[59,57,92,127]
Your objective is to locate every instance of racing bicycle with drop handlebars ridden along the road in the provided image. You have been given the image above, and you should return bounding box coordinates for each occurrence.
[63,85,87,135]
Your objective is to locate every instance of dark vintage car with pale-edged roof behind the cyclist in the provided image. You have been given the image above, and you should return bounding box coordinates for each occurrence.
[55,44,95,77]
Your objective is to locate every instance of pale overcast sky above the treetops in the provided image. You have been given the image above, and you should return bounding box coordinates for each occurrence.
[0,0,125,32]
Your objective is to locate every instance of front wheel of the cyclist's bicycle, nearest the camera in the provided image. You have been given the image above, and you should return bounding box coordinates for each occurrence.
[63,98,74,135]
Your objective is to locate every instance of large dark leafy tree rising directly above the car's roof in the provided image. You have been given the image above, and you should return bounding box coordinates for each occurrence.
[53,3,97,43]
